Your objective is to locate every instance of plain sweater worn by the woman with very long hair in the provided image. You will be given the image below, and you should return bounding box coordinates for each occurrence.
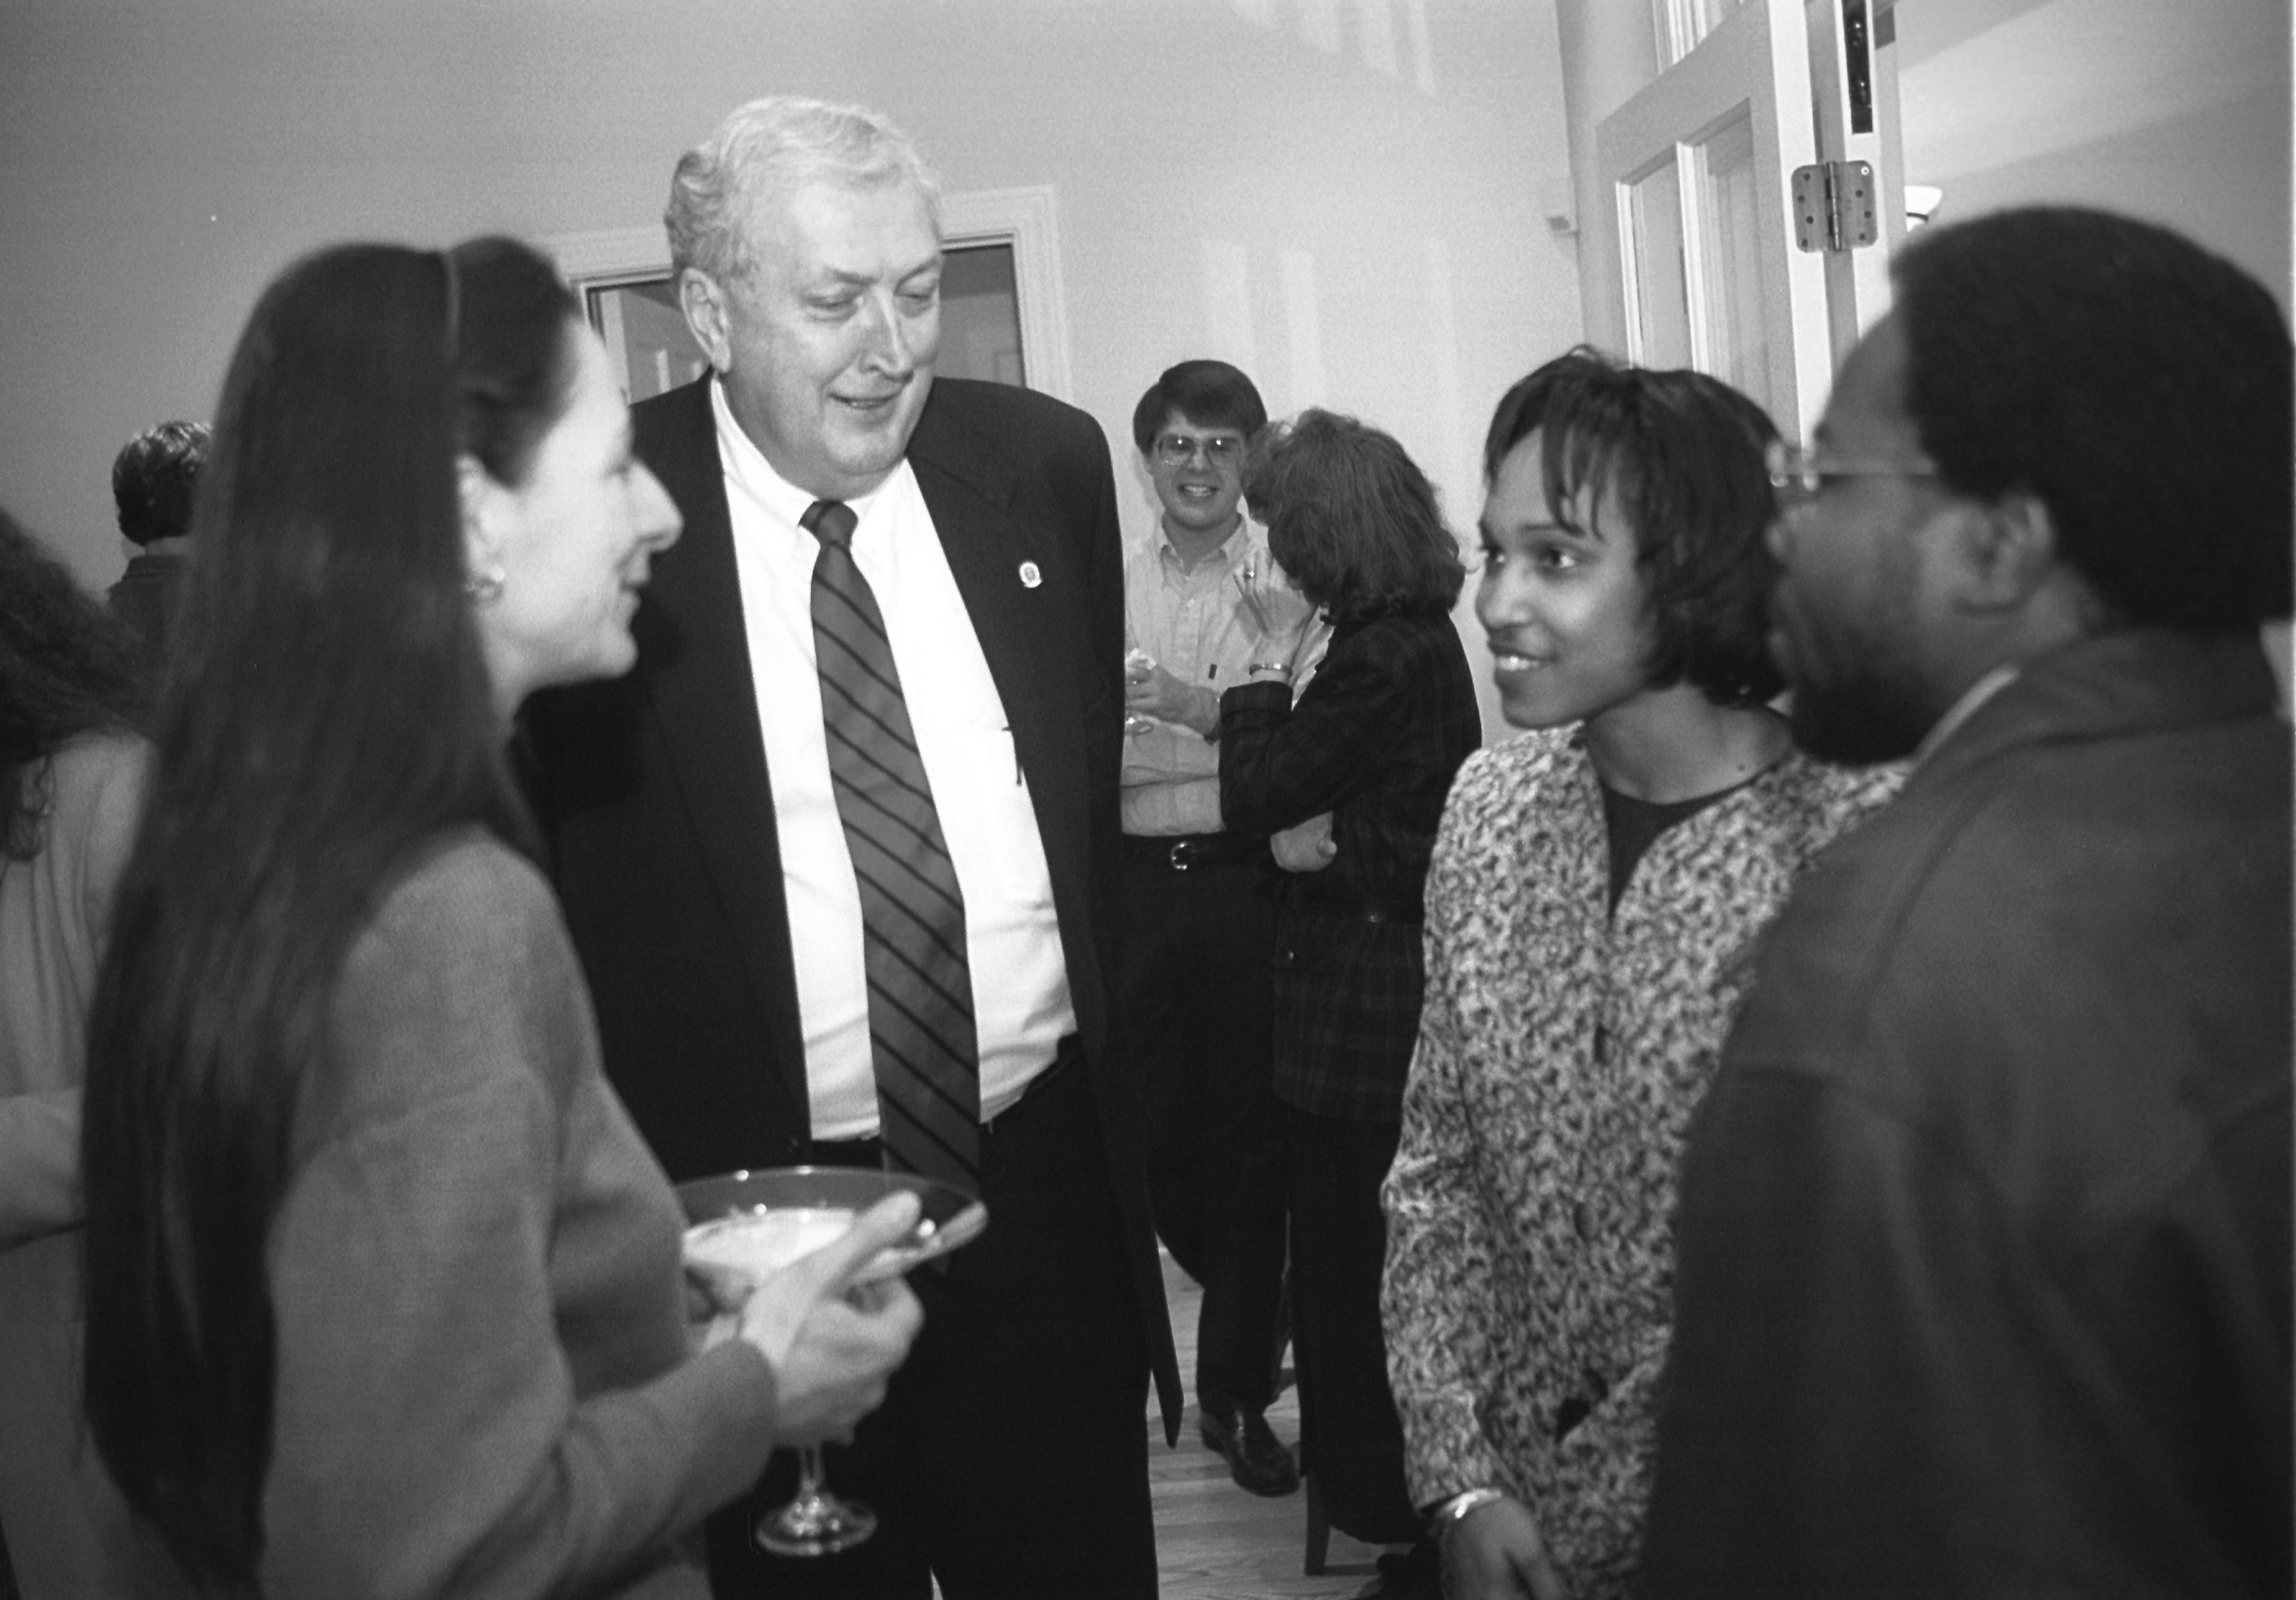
[262,831,773,1600]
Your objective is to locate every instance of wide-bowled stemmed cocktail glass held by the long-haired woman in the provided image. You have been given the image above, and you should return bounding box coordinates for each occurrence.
[677,1166,989,1556]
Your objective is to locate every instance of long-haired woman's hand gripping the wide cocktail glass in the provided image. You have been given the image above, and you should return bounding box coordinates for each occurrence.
[740,1193,925,1444]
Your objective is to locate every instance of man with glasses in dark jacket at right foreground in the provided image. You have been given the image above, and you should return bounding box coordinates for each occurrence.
[1637,209,2296,1595]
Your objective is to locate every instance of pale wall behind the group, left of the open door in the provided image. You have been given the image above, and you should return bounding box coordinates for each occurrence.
[0,0,1580,743]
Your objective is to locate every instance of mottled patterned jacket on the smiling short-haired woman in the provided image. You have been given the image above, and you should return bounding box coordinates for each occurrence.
[1382,732,1899,1595]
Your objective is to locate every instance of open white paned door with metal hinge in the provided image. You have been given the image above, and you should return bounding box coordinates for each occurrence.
[1566,0,1903,439]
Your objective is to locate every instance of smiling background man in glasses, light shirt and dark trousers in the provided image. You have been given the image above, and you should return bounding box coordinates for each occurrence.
[1119,360,1329,1494]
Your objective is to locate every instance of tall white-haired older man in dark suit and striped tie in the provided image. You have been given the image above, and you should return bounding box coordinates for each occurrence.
[528,99,1177,1600]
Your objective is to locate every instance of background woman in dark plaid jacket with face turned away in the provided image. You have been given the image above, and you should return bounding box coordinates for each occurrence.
[1220,411,1480,1588]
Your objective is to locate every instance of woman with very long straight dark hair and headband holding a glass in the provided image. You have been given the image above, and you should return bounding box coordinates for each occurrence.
[82,238,917,1600]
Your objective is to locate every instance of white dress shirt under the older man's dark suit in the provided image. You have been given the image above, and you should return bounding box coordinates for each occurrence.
[710,381,1076,1139]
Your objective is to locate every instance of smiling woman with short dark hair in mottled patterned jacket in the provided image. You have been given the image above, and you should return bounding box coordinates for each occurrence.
[1382,349,1892,1600]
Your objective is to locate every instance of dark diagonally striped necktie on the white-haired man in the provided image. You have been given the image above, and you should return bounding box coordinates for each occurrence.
[799,500,980,1193]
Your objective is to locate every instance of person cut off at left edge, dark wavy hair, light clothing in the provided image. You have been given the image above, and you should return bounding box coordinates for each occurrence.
[0,512,183,1600]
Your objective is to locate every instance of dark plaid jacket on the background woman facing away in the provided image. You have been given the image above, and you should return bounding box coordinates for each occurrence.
[1220,613,1480,1122]
